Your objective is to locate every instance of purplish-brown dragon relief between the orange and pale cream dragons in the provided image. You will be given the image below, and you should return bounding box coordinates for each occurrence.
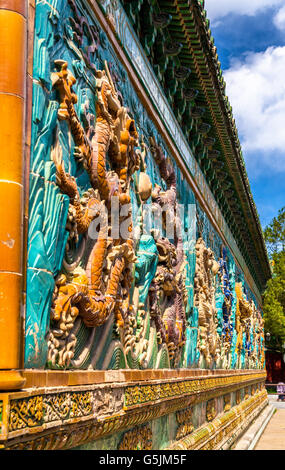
[145,138,187,366]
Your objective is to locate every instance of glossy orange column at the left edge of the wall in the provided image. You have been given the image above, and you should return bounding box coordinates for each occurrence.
[0,0,27,390]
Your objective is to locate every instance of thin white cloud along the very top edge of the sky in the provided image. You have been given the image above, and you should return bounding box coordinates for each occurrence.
[205,0,284,21]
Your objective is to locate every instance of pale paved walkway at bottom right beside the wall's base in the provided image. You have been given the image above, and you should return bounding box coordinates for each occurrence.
[254,395,285,450]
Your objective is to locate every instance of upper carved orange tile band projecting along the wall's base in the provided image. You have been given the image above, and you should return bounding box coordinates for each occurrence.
[0,371,266,449]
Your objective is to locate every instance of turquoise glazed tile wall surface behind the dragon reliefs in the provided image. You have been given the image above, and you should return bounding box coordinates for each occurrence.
[25,0,263,370]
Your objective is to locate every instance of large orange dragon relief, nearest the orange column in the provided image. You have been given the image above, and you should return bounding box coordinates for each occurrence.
[48,60,139,367]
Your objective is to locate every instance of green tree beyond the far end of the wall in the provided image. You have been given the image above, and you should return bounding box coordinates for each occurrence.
[263,207,285,349]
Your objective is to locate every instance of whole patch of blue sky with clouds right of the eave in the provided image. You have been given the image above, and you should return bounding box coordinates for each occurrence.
[205,0,285,227]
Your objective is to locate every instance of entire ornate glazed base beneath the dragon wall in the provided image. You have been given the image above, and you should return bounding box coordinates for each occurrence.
[0,370,268,450]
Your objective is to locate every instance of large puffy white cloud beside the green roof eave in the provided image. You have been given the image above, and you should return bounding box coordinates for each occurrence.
[224,46,285,171]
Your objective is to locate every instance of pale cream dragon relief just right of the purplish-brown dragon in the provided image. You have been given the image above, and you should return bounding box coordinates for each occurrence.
[194,238,221,366]
